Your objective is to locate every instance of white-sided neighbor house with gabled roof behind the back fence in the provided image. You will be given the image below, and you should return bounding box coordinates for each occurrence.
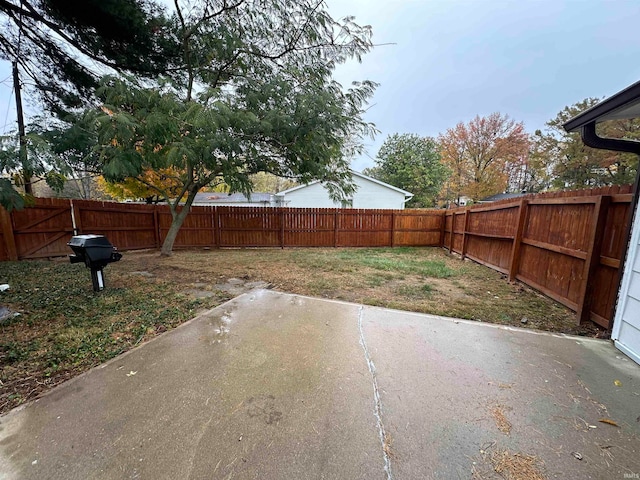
[275,170,413,210]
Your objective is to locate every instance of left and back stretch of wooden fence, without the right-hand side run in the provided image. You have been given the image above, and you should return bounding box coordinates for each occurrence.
[0,199,444,260]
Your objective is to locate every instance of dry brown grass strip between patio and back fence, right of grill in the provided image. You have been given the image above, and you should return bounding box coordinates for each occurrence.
[110,248,602,336]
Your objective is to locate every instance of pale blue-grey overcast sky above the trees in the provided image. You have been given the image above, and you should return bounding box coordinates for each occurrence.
[0,0,640,170]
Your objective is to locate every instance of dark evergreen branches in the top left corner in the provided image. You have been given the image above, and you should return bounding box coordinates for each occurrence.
[0,0,179,113]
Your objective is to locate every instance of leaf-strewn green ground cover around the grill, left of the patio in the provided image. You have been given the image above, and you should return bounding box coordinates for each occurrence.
[0,261,228,412]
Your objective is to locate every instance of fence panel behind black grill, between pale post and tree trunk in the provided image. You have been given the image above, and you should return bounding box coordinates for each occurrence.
[73,200,158,250]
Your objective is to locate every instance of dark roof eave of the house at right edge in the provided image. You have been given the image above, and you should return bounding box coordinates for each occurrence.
[563,82,640,132]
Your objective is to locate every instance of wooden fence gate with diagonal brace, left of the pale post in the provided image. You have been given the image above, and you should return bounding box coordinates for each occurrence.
[10,198,73,259]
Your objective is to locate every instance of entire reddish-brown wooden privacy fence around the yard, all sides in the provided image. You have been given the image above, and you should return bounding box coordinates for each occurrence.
[0,186,632,328]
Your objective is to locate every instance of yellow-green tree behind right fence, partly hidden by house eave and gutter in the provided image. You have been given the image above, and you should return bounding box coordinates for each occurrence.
[533,98,640,189]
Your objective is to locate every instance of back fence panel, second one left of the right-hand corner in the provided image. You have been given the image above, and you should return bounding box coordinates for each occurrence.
[336,209,393,247]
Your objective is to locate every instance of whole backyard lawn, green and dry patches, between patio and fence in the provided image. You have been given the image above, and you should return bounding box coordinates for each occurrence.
[0,248,602,412]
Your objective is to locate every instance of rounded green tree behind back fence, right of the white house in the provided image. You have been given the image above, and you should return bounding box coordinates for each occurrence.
[364,133,449,208]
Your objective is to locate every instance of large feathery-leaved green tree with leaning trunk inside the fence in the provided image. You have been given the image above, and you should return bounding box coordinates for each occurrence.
[98,0,375,255]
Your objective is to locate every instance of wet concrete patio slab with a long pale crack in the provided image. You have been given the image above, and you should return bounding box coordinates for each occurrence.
[0,290,640,480]
